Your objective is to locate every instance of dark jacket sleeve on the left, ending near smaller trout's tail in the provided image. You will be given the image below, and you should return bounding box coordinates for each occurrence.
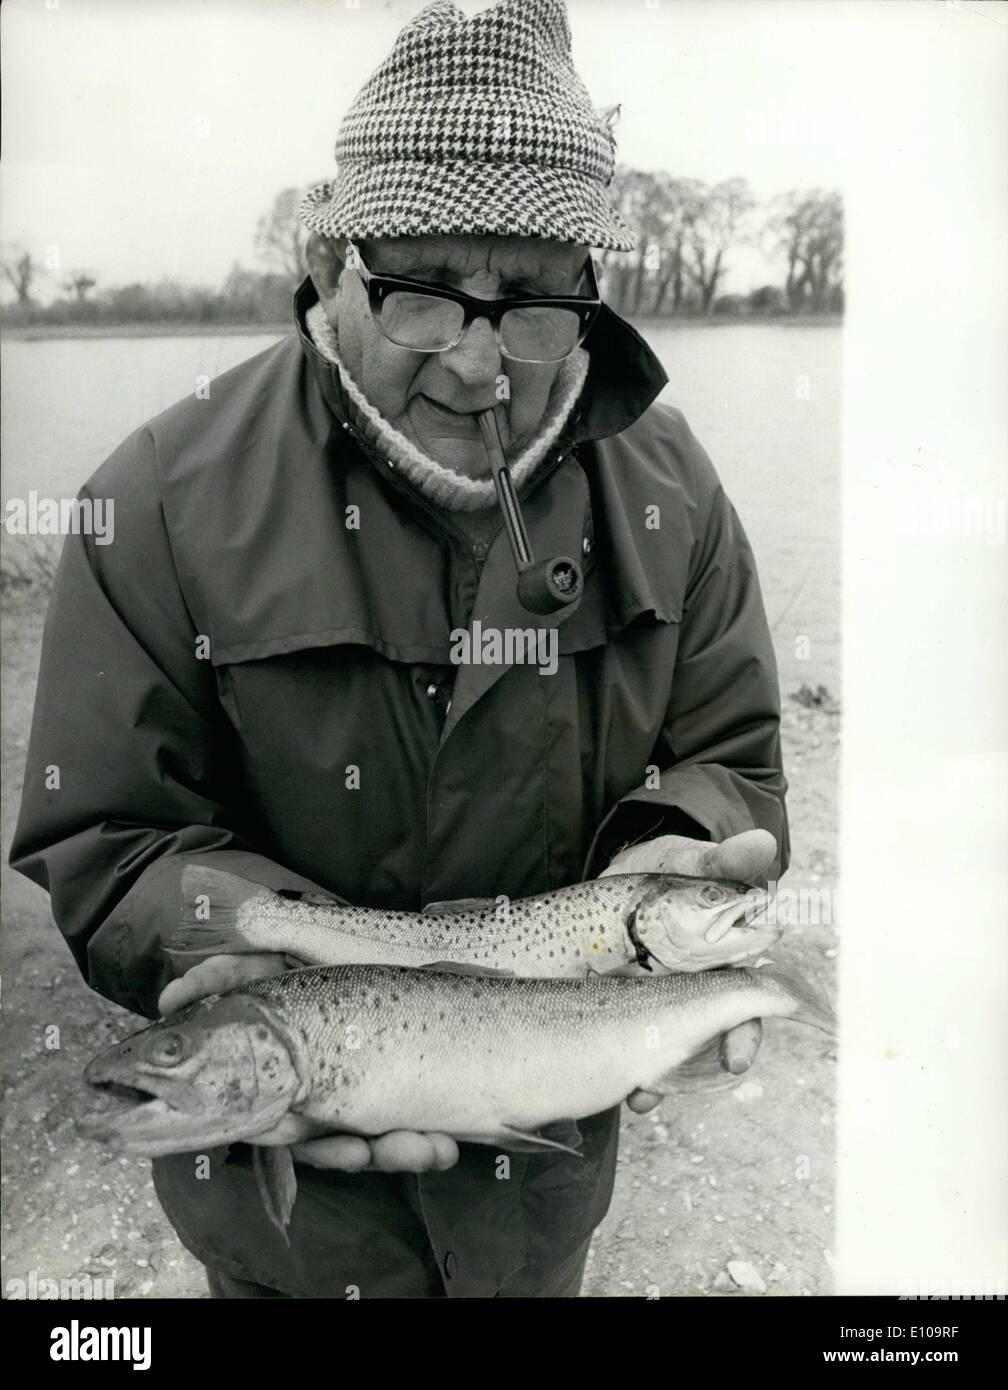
[11,430,323,1017]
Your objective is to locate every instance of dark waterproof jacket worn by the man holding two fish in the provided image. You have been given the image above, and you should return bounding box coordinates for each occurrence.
[11,281,788,1297]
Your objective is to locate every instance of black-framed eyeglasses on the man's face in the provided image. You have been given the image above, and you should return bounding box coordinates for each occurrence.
[346,242,602,361]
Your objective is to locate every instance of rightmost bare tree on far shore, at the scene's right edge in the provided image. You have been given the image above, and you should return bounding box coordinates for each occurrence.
[767,189,844,313]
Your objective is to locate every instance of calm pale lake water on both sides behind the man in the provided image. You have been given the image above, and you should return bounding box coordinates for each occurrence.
[0,324,841,692]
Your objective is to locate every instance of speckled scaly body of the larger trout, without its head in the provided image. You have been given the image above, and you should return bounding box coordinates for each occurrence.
[243,966,817,1138]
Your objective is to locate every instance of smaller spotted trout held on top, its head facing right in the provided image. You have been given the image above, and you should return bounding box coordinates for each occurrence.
[165,865,781,980]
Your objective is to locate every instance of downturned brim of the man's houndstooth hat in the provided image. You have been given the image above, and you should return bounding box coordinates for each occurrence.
[294,160,637,252]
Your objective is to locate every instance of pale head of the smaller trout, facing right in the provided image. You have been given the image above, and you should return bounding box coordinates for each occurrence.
[631,874,781,970]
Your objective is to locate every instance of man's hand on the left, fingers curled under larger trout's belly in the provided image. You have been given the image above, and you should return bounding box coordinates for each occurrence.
[157,951,459,1173]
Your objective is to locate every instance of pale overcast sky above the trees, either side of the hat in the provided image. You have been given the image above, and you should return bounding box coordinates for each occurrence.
[0,0,850,296]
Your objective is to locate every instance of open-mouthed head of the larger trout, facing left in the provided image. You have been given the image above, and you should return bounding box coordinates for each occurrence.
[79,994,304,1158]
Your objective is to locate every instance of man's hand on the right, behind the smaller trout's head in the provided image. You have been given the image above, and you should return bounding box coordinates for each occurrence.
[599,830,777,1115]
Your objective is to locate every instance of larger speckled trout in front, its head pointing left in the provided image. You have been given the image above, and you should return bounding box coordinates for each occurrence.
[82,966,834,1236]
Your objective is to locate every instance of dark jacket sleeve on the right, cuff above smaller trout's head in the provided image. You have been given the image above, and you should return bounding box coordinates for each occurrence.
[585,425,790,878]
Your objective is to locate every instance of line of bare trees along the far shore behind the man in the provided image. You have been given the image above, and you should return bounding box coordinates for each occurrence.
[0,176,844,328]
